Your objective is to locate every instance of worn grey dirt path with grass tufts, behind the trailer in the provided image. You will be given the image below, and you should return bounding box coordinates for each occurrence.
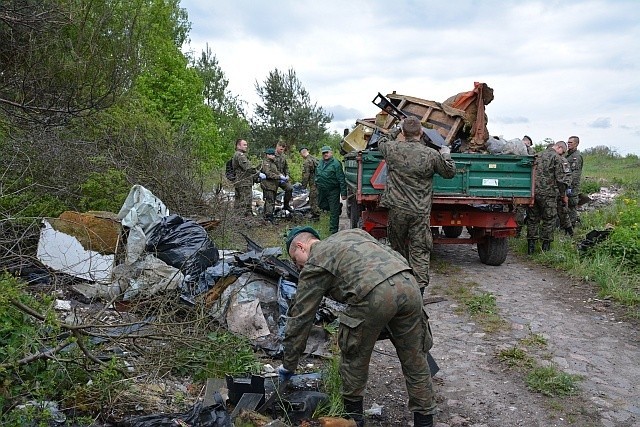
[365,245,640,427]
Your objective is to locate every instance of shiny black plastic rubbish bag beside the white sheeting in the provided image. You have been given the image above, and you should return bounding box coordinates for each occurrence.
[145,215,218,278]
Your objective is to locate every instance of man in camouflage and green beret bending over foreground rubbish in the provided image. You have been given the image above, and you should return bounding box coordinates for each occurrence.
[278,227,436,427]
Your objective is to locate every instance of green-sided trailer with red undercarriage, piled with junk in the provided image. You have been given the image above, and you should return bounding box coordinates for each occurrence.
[343,89,534,265]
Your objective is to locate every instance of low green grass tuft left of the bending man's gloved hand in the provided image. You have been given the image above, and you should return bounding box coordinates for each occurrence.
[172,331,261,380]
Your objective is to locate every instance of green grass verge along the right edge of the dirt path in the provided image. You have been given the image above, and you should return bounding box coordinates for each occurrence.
[511,151,640,319]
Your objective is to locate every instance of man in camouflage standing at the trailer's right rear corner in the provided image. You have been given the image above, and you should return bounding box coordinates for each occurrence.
[527,141,569,255]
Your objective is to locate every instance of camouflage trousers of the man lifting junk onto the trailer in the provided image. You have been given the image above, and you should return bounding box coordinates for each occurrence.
[387,209,433,288]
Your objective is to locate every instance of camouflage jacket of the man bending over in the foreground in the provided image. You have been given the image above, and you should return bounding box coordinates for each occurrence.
[282,228,417,371]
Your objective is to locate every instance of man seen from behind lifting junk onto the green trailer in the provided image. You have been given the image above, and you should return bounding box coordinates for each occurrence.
[378,117,456,292]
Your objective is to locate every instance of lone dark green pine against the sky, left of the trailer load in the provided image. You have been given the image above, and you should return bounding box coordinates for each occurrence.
[251,69,333,150]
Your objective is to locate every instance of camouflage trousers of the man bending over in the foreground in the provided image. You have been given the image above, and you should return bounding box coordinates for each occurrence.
[338,271,436,414]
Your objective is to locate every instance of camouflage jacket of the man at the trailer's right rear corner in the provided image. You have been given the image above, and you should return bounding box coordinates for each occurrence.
[535,147,571,197]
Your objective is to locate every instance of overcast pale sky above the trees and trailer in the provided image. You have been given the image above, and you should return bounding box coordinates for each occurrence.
[181,0,640,154]
